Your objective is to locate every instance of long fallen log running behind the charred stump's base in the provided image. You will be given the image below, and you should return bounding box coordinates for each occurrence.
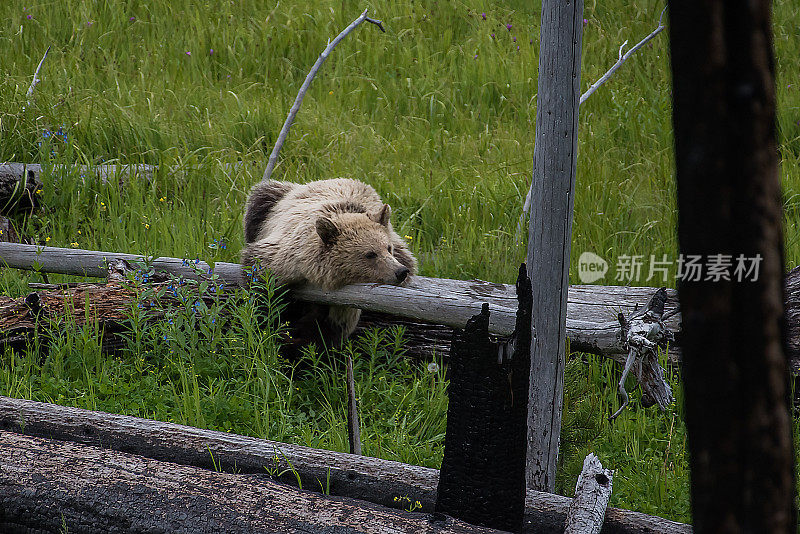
[0,397,691,534]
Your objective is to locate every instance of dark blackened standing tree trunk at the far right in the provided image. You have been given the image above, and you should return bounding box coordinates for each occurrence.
[670,0,797,533]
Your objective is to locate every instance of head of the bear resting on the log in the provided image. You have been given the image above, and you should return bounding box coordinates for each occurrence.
[316,204,410,286]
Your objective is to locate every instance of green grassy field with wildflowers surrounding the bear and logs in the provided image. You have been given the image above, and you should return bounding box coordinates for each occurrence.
[0,0,800,521]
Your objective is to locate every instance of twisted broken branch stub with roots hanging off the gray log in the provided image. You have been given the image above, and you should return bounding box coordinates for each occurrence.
[609,287,675,421]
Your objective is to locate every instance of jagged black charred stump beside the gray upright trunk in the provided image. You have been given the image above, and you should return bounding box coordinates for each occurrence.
[436,264,531,532]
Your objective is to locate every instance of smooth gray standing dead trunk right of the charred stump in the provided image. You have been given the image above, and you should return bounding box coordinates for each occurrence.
[526,0,583,492]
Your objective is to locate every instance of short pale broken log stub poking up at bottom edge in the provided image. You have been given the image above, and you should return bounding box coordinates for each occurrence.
[564,452,614,534]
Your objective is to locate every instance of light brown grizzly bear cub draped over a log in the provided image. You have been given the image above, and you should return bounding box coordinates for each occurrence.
[241,178,417,350]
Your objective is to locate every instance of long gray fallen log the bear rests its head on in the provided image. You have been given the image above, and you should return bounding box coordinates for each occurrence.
[0,243,680,364]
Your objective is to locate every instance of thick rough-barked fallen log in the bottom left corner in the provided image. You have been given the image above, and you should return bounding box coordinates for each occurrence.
[0,431,501,534]
